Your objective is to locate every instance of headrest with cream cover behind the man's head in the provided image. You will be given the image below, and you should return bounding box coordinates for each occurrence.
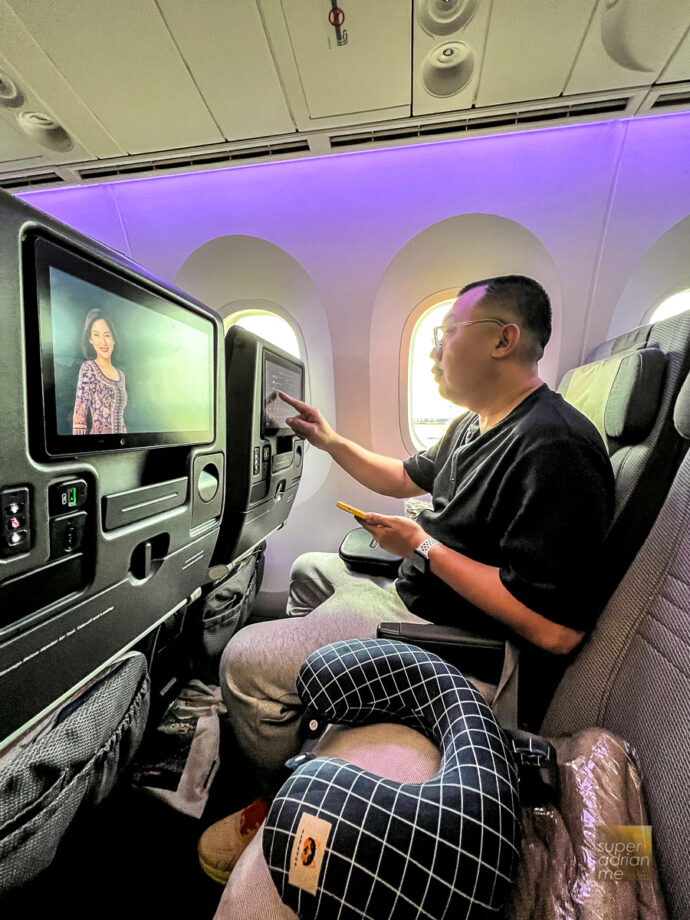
[558,348,666,446]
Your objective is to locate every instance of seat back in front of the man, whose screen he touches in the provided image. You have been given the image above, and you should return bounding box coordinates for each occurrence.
[183,326,305,683]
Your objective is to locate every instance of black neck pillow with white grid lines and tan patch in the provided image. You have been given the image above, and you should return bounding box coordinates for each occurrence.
[263,639,521,920]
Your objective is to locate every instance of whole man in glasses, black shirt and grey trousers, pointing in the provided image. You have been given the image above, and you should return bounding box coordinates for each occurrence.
[221,276,613,800]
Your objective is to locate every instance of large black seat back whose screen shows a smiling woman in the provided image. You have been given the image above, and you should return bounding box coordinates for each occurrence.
[0,190,225,891]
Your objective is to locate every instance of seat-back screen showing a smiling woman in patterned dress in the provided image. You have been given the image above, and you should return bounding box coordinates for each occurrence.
[29,238,215,456]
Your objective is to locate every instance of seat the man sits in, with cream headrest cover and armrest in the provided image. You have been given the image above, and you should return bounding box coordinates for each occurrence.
[377,312,690,726]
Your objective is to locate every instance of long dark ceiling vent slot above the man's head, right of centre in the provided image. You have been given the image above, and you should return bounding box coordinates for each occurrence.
[331,96,630,148]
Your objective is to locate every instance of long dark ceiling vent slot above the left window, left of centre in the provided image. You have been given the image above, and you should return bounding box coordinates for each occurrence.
[77,138,309,179]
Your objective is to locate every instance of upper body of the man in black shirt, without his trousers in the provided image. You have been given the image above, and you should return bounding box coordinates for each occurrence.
[287,275,613,654]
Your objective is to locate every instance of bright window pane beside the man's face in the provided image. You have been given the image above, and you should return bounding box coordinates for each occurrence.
[407,297,468,450]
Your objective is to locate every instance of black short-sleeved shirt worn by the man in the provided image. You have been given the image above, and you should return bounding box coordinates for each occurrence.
[396,384,614,635]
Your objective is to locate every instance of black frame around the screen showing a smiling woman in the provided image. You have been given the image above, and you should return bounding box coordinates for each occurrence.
[24,233,217,457]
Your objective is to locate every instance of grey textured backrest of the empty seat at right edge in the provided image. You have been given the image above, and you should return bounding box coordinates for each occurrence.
[542,374,690,920]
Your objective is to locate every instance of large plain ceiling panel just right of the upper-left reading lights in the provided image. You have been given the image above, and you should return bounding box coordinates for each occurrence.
[11,0,223,153]
